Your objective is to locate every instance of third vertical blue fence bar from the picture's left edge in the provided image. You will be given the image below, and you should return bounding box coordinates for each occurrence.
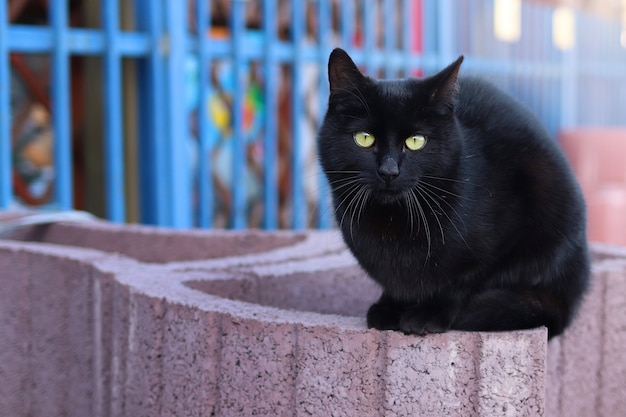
[100,0,126,223]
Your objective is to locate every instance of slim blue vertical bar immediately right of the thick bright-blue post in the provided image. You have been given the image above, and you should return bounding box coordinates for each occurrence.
[196,0,215,228]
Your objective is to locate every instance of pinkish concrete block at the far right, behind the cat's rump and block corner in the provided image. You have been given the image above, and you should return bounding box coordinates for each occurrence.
[546,260,626,417]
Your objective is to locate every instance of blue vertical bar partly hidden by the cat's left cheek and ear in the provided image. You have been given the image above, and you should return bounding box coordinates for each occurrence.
[315,0,332,229]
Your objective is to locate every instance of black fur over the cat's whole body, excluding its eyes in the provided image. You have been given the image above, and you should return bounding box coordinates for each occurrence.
[318,49,589,337]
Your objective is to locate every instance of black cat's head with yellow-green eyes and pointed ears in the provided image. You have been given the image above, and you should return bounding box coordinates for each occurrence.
[318,49,463,203]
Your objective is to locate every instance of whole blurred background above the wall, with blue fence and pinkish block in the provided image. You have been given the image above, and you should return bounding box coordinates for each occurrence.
[0,0,626,240]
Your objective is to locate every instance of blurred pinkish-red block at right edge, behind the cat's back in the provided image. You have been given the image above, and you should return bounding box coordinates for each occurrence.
[559,128,626,246]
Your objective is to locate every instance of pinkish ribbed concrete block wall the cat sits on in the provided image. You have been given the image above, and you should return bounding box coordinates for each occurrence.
[0,222,626,417]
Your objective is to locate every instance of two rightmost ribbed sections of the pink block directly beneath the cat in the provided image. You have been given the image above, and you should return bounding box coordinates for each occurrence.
[386,329,546,416]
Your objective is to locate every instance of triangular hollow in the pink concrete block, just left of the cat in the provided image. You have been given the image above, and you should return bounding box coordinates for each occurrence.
[184,266,381,318]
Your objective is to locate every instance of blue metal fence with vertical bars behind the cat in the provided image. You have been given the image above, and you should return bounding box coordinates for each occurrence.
[0,0,626,229]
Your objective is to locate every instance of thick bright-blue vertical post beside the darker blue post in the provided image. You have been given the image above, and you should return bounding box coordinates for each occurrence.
[165,1,192,228]
